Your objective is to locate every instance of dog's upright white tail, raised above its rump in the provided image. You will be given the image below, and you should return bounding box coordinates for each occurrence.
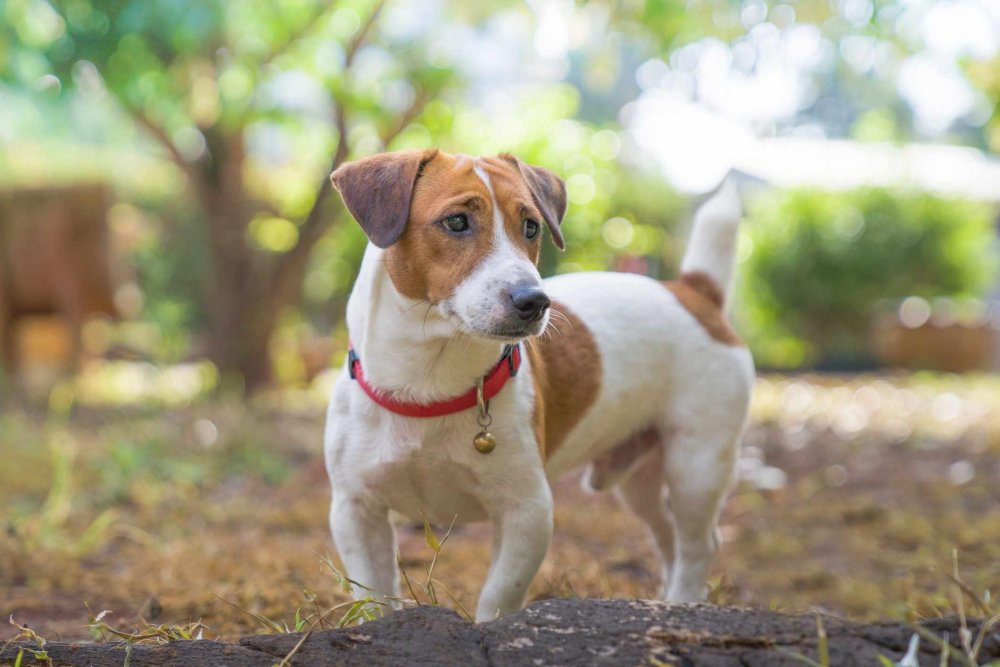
[681,174,743,309]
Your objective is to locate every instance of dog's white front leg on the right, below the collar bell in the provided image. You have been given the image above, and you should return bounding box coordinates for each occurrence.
[476,483,552,623]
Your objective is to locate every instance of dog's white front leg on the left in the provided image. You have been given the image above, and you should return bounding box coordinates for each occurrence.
[330,492,399,608]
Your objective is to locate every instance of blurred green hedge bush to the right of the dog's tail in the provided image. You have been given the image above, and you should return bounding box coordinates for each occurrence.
[741,189,996,367]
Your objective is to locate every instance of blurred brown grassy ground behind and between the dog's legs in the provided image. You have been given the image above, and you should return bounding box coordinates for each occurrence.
[0,375,1000,639]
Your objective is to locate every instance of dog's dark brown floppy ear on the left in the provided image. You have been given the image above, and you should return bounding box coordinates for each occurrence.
[330,150,437,248]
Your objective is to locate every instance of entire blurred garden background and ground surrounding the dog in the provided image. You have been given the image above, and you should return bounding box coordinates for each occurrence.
[0,0,1000,638]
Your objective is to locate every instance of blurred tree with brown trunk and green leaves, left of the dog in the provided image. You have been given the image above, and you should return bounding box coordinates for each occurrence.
[0,0,457,390]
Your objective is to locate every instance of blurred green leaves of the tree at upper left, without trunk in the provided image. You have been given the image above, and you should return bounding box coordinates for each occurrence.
[0,0,464,211]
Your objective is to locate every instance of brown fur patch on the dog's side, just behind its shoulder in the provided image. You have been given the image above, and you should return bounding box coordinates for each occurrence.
[525,301,603,460]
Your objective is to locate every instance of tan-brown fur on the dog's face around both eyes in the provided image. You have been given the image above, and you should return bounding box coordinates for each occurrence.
[384,152,542,303]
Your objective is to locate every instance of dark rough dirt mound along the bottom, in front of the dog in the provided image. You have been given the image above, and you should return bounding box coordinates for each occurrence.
[0,599,1000,667]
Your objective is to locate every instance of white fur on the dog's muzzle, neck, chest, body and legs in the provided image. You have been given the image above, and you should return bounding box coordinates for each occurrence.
[325,170,754,621]
